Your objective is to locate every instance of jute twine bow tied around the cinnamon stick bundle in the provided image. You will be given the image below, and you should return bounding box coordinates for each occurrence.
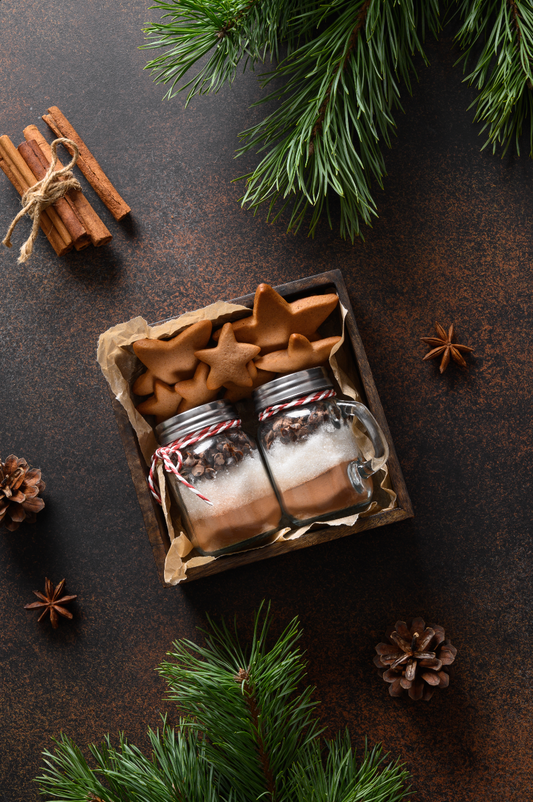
[2,138,81,264]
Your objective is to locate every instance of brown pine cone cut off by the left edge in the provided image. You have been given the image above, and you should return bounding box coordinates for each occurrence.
[0,454,45,532]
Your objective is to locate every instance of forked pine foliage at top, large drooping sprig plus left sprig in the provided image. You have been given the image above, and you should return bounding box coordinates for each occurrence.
[144,0,438,240]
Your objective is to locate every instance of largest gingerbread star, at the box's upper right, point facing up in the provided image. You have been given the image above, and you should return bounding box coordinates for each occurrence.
[213,284,339,354]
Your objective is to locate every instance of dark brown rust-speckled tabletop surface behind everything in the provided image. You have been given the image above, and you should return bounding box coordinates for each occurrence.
[0,0,533,802]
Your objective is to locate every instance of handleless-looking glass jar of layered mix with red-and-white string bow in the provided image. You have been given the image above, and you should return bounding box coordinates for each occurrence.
[149,401,281,556]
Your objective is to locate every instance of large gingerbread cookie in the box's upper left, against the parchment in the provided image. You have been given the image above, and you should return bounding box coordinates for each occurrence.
[133,320,213,384]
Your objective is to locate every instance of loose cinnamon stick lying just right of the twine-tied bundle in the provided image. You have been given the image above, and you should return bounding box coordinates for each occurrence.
[43,106,131,220]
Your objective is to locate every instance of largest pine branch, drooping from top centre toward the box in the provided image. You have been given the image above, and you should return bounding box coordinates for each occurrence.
[239,0,438,241]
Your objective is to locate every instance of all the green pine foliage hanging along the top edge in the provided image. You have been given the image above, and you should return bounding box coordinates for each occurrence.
[143,0,533,241]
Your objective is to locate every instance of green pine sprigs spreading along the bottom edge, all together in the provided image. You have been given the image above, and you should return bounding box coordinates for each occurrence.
[37,610,408,802]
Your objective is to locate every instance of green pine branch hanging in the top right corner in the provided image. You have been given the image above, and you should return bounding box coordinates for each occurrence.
[450,0,533,157]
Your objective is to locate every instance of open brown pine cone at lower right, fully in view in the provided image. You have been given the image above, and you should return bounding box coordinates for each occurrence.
[374,618,457,702]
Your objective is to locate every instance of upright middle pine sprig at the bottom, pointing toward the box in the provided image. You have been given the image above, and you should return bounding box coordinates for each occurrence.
[160,604,319,800]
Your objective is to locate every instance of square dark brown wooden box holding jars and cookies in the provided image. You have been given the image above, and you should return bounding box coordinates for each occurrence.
[112,270,413,587]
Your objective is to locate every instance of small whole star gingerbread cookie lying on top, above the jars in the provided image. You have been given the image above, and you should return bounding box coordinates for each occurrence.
[195,323,261,390]
